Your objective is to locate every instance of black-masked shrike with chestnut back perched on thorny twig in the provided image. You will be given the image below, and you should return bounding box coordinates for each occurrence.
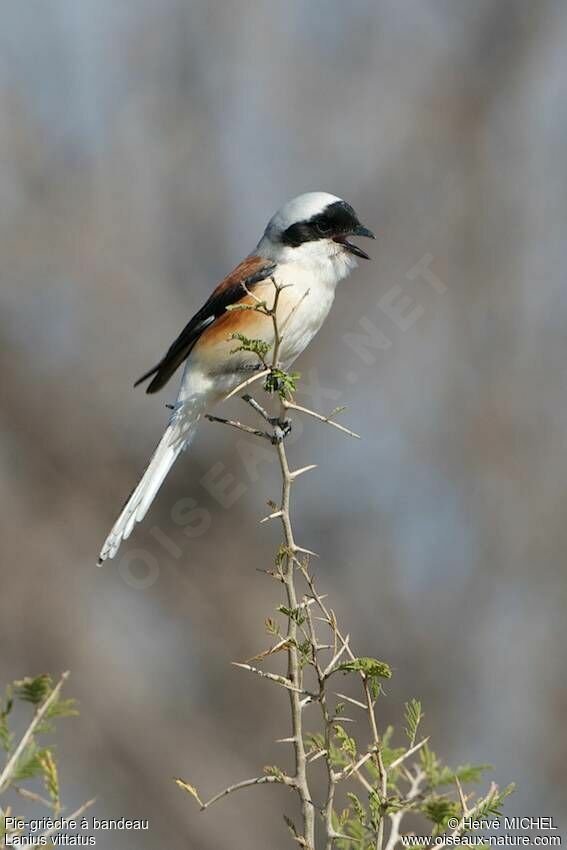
[98,192,376,565]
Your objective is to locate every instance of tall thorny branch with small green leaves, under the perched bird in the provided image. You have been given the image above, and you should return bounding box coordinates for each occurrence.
[177,278,510,850]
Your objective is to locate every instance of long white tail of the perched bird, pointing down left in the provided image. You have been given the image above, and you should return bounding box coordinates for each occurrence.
[98,401,202,566]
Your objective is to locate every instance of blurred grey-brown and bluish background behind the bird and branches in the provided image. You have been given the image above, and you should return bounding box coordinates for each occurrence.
[0,0,567,850]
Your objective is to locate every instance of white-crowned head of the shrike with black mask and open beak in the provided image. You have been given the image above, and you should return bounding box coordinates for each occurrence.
[258,192,376,276]
